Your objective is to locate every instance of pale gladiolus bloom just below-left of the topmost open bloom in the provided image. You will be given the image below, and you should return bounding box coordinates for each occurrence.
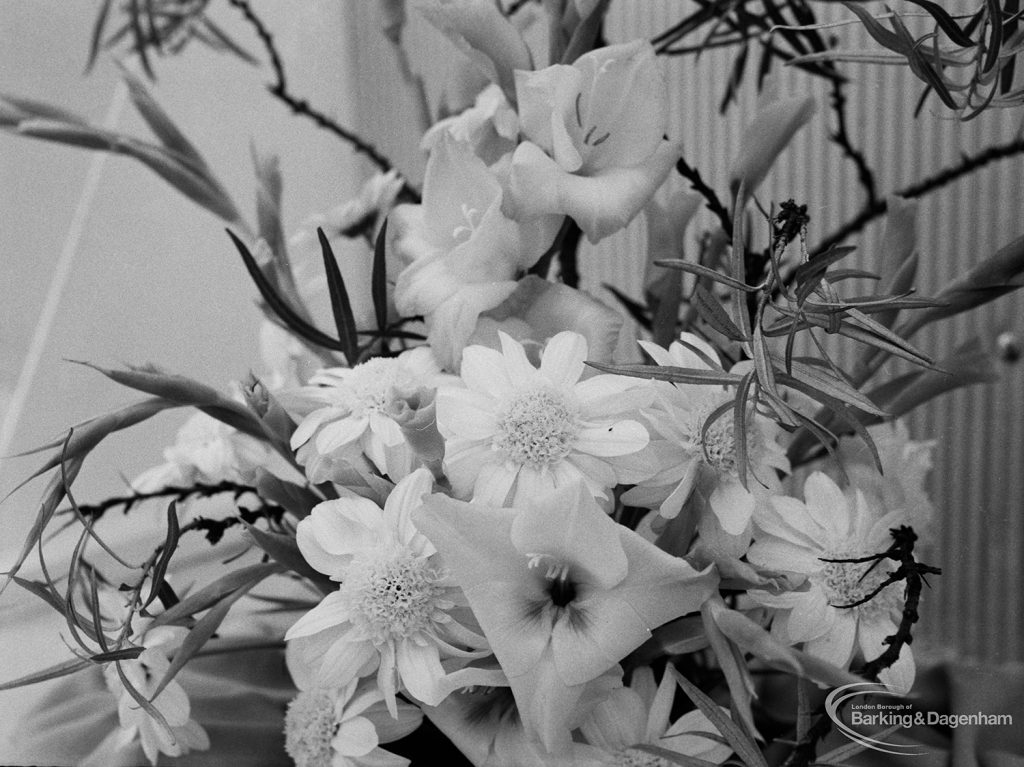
[389,134,558,370]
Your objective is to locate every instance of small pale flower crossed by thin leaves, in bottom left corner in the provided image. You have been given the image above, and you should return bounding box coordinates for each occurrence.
[103,627,210,765]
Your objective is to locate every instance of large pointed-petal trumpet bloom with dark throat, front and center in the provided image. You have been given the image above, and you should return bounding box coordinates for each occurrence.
[415,484,718,752]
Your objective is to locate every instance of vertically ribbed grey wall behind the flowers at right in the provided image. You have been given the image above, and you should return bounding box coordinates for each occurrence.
[358,0,1024,661]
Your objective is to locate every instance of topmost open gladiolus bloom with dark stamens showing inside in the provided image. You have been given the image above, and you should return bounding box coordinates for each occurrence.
[505,40,679,243]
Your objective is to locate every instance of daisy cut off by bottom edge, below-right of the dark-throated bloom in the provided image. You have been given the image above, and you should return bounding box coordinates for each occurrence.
[580,667,732,767]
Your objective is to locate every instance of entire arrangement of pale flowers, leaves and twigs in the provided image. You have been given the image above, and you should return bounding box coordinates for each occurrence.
[0,0,1024,767]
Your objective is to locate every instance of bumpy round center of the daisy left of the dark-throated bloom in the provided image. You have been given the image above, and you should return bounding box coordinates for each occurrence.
[339,546,454,644]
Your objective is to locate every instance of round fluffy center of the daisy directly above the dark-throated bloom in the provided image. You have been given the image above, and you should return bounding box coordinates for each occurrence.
[493,389,580,468]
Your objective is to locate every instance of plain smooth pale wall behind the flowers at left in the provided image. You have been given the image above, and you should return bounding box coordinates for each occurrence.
[0,0,367,763]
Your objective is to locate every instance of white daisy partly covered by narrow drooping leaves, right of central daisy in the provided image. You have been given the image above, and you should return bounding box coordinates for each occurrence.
[624,333,790,536]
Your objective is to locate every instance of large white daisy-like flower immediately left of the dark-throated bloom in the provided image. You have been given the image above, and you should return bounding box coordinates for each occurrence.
[285,469,504,714]
